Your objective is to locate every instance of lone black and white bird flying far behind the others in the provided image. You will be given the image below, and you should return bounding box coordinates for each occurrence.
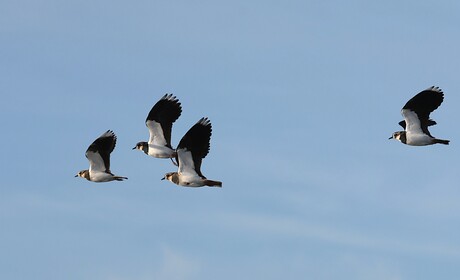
[389,86,449,146]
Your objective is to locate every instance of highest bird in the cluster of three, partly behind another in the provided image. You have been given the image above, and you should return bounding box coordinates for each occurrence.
[133,94,182,162]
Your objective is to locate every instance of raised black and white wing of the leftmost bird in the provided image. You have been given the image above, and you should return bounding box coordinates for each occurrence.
[86,130,117,173]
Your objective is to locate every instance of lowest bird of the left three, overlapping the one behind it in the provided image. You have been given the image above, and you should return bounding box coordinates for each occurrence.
[162,118,222,187]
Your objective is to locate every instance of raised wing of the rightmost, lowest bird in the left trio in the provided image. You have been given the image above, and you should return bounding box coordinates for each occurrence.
[176,118,212,178]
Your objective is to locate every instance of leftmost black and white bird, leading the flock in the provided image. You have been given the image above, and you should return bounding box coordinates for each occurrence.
[75,130,128,182]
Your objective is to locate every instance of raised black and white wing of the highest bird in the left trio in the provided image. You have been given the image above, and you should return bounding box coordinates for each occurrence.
[145,94,182,148]
